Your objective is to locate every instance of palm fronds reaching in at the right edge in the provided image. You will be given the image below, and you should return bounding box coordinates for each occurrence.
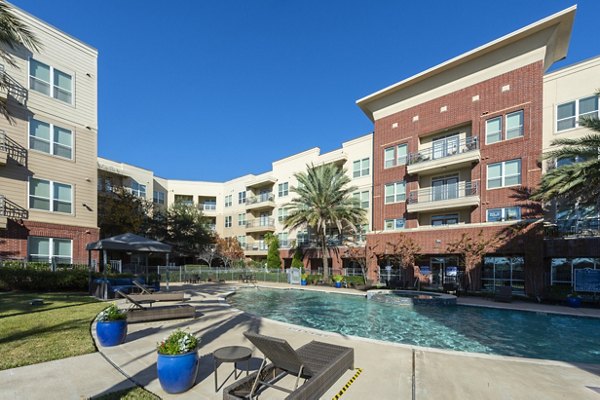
[531,114,600,205]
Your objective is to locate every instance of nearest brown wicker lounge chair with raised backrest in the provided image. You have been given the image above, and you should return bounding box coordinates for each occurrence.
[223,332,354,400]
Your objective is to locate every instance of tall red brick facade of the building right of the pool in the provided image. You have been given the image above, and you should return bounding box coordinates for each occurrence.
[367,62,543,289]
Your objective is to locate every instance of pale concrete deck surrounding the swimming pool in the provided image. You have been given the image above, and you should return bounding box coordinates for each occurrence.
[0,284,600,400]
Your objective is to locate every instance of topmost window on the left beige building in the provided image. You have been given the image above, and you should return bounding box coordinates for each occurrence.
[29,59,73,104]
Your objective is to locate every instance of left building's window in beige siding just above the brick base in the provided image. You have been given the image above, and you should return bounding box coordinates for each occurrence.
[29,178,73,214]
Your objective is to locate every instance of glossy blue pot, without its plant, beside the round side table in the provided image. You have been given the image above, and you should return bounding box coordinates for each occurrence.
[156,351,199,393]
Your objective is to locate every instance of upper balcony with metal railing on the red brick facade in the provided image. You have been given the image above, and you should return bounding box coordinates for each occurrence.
[407,137,481,174]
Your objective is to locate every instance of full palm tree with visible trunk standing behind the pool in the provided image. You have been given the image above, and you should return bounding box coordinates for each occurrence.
[283,164,366,280]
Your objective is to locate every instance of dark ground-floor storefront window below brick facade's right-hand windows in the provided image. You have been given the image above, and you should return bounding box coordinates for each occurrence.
[481,256,525,292]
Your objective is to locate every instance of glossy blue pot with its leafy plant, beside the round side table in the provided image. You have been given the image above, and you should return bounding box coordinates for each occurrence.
[156,329,200,393]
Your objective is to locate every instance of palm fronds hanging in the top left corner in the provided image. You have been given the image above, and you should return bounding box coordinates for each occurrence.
[0,0,42,121]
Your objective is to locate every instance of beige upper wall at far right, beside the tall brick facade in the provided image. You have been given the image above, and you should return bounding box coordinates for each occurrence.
[543,56,600,171]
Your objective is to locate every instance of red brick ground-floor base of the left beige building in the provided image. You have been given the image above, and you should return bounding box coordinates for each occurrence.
[0,219,100,264]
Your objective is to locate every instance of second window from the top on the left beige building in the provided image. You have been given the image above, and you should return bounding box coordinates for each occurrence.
[29,119,73,159]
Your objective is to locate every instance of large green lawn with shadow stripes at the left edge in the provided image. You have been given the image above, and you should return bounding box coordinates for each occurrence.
[0,292,108,370]
